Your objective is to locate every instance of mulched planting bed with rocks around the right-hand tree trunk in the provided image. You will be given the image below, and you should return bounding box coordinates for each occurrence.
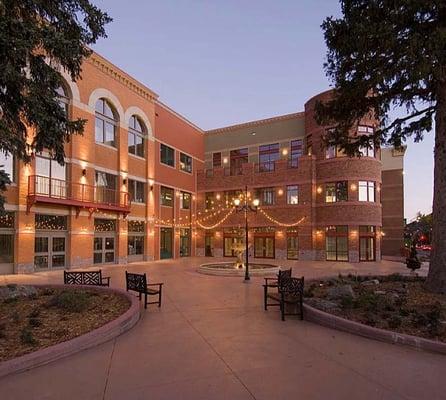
[304,274,446,343]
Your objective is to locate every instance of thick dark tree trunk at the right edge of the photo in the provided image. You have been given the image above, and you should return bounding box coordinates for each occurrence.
[426,81,446,293]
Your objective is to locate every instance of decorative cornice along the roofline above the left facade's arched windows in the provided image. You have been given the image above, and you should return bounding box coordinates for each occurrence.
[86,52,158,101]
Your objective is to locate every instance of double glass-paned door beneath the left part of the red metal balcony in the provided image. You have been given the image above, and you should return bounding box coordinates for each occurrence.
[34,234,66,269]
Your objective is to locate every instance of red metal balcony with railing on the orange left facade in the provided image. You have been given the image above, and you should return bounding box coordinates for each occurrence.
[26,175,130,216]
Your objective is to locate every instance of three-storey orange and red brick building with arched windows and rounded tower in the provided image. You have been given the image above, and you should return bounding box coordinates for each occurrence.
[0,53,403,274]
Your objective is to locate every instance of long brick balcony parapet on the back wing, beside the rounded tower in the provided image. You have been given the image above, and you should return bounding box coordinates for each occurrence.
[197,156,315,191]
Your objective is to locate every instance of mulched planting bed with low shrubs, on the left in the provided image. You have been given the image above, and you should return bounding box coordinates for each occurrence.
[0,285,130,362]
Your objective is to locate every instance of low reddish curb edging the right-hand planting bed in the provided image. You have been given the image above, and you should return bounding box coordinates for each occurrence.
[304,304,446,354]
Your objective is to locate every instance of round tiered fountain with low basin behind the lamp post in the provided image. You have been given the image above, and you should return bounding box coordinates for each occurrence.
[197,243,280,276]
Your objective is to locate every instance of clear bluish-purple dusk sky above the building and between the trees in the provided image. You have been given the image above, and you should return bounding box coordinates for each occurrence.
[93,0,434,221]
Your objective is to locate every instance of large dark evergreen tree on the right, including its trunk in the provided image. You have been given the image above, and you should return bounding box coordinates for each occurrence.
[316,0,446,292]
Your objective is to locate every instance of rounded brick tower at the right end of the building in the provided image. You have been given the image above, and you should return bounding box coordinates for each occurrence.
[305,90,382,262]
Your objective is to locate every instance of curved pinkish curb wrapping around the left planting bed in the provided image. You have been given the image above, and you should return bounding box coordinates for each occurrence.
[0,285,141,378]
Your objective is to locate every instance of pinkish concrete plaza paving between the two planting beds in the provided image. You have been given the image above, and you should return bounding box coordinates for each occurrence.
[0,258,440,400]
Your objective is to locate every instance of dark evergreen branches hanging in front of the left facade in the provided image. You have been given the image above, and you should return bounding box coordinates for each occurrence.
[0,0,111,210]
